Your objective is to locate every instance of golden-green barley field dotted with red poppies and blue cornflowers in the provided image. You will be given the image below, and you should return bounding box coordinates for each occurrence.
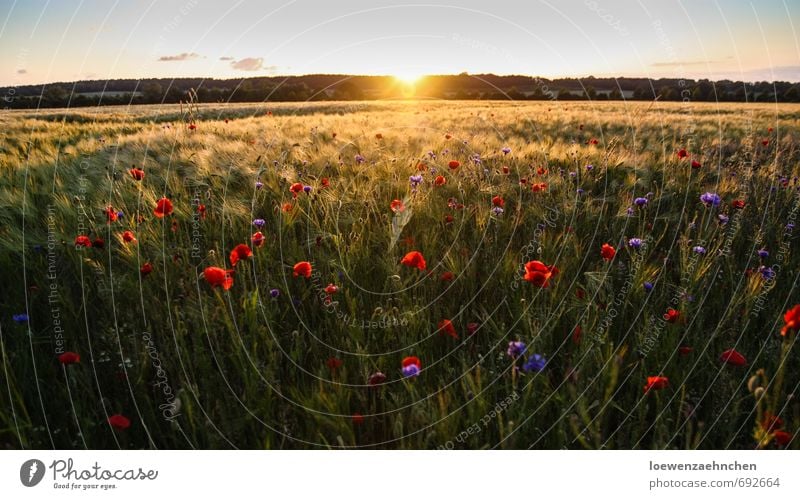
[0,101,800,449]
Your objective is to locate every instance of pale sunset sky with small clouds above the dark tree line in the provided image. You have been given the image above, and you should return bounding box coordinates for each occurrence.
[0,0,800,85]
